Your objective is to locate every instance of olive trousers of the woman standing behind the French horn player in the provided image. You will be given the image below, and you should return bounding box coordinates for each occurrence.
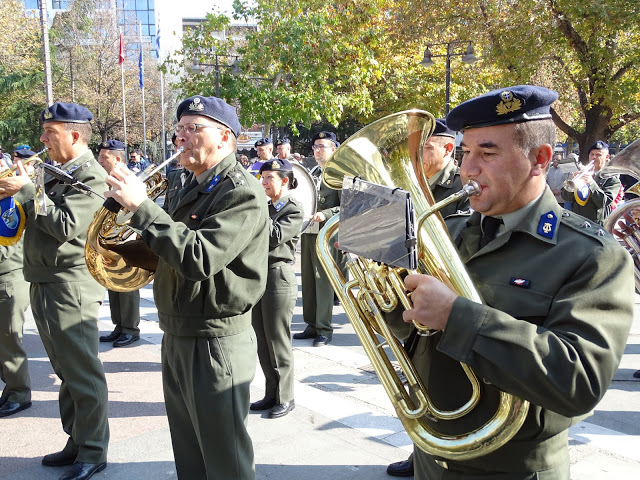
[251,263,298,403]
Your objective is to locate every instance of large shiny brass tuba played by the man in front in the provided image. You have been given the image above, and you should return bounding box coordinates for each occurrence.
[316,110,529,461]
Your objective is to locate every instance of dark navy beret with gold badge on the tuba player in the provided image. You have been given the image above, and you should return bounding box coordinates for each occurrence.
[446,85,558,131]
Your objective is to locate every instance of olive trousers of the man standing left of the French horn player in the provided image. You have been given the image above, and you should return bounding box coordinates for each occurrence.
[31,279,109,463]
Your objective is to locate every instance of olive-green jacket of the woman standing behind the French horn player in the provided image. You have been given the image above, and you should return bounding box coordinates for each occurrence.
[269,195,303,267]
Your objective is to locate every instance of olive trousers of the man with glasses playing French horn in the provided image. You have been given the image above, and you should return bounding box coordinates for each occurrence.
[162,328,256,480]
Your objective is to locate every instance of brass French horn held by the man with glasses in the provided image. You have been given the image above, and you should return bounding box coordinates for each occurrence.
[84,147,184,292]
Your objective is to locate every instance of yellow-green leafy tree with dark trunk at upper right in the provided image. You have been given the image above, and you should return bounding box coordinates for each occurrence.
[391,0,640,158]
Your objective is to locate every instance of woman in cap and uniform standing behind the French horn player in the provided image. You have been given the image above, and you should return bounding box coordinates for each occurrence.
[250,159,303,418]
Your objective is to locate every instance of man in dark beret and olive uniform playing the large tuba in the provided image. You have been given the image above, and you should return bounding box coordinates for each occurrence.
[395,85,634,480]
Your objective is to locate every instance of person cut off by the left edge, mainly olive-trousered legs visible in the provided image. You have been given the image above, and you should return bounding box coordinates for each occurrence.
[0,163,31,418]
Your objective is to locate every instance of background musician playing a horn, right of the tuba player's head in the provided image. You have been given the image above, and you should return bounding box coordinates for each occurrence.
[561,140,621,225]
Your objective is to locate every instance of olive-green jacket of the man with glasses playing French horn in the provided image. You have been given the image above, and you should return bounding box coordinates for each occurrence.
[131,154,269,336]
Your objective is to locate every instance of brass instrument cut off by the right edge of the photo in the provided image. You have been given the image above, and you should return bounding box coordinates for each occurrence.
[602,139,640,292]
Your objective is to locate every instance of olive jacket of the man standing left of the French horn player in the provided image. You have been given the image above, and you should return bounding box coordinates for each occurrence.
[14,150,107,282]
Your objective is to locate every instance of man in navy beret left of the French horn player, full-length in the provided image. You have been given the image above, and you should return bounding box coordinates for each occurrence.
[0,103,109,480]
